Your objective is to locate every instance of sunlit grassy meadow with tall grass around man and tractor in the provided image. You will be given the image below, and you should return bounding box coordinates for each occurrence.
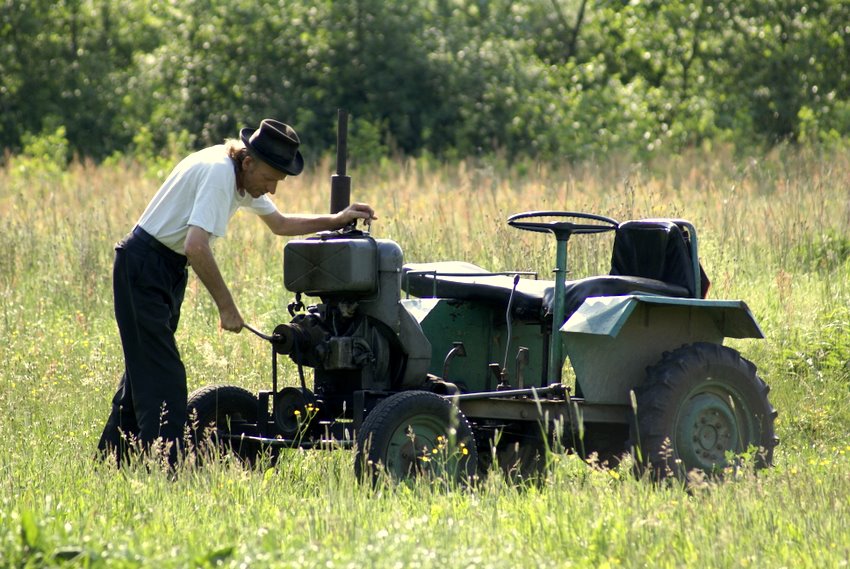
[0,144,850,568]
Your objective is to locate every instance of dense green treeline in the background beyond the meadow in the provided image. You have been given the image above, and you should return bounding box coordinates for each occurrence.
[0,0,850,164]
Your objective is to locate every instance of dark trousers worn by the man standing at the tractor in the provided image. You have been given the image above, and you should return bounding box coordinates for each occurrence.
[98,227,188,465]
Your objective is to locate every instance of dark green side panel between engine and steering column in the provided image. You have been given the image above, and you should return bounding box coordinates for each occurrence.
[401,298,547,391]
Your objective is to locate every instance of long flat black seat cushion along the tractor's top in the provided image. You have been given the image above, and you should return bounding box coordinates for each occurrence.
[401,261,690,320]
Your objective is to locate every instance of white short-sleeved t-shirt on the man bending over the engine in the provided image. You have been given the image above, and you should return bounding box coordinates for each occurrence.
[138,144,277,255]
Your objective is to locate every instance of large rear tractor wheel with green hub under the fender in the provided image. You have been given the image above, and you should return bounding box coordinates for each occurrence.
[631,343,777,478]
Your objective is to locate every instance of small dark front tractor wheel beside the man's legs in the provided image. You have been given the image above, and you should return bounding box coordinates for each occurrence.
[187,385,257,458]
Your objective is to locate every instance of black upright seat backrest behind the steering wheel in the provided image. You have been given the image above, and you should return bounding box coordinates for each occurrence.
[610,219,709,298]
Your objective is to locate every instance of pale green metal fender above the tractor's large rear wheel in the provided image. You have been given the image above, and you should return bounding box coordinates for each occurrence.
[561,295,763,405]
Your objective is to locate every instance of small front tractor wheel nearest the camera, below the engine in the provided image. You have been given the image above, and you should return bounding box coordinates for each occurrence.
[354,391,478,483]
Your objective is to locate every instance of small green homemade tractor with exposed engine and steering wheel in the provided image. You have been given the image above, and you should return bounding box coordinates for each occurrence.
[189,112,777,480]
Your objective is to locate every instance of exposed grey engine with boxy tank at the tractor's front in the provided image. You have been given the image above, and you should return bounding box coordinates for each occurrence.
[274,231,431,414]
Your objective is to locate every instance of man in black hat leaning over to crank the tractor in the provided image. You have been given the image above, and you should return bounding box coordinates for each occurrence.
[98,119,375,465]
